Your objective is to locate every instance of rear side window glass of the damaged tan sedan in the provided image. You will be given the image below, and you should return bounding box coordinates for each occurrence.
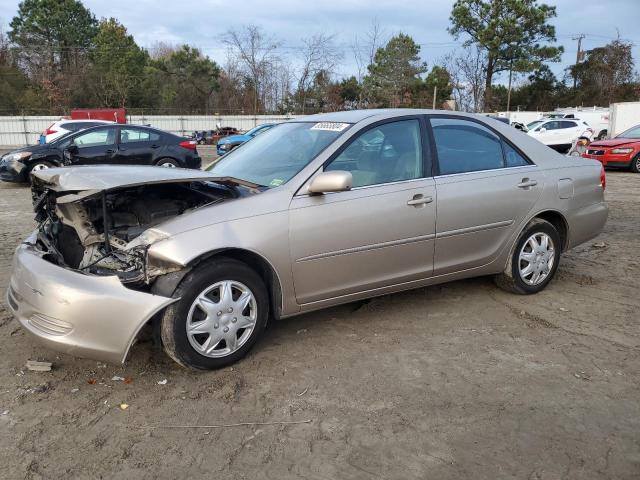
[430,118,530,175]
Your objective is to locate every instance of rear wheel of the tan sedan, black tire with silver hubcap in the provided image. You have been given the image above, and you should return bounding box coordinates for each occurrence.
[495,218,562,295]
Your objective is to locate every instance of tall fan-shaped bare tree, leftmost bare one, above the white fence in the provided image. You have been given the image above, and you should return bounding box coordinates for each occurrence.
[222,25,280,115]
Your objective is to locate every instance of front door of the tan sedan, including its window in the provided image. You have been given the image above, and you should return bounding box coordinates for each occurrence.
[289,118,436,304]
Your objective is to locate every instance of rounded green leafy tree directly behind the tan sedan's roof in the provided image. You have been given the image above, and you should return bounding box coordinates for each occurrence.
[364,33,427,107]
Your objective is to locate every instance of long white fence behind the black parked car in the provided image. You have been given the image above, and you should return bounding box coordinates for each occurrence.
[0,115,296,146]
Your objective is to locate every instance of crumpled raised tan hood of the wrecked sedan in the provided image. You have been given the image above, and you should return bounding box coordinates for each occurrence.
[32,165,255,192]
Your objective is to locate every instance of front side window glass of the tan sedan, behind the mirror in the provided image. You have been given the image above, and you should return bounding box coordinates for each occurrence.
[325,120,423,188]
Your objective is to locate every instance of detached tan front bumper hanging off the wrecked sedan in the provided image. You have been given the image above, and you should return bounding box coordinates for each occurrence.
[6,236,176,363]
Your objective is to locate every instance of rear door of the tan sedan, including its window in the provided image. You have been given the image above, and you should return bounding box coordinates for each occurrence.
[430,116,544,275]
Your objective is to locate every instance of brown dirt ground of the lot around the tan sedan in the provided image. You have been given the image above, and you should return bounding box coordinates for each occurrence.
[0,156,640,480]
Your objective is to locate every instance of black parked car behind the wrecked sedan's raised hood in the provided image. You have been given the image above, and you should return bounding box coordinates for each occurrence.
[0,124,202,182]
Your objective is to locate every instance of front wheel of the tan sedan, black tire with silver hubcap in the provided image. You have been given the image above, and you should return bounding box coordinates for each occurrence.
[160,258,269,370]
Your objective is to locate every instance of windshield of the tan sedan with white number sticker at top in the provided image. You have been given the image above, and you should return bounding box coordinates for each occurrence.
[207,122,350,188]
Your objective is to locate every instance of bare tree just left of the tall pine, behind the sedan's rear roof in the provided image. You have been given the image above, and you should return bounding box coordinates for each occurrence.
[440,47,486,112]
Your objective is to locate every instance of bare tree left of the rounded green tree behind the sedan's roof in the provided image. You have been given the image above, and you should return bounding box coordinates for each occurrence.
[297,33,342,114]
